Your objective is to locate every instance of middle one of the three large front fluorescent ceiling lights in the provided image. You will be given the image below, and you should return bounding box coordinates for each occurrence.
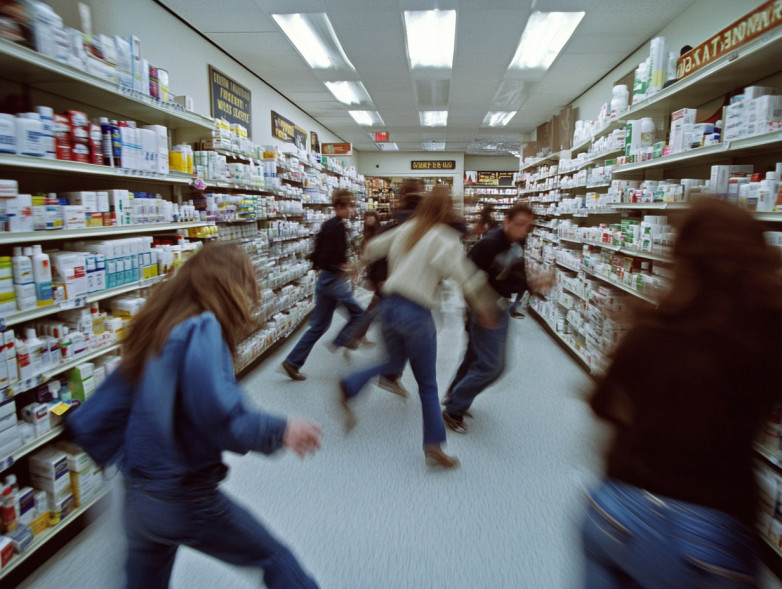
[404,10,456,69]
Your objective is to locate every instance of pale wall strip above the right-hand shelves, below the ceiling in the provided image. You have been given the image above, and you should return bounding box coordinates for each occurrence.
[568,0,762,129]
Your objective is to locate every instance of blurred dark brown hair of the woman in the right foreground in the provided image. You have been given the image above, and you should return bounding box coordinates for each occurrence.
[646,197,782,331]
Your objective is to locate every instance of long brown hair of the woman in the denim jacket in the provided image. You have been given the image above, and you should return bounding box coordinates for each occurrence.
[119,243,258,383]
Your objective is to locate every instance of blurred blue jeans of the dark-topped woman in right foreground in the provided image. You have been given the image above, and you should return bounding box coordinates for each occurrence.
[582,479,757,589]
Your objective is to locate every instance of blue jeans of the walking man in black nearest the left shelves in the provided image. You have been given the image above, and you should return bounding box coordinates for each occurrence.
[285,270,364,368]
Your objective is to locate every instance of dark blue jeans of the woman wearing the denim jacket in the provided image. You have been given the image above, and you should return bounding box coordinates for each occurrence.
[125,481,318,589]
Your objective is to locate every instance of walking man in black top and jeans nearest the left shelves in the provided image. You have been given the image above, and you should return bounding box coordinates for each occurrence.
[282,189,364,380]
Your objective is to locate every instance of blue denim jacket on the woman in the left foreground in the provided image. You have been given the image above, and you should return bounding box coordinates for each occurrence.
[68,312,287,493]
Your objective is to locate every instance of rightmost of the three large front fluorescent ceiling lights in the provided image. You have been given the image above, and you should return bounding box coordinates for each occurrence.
[509,12,585,70]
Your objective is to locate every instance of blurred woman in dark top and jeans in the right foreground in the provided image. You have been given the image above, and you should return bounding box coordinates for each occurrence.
[582,197,782,589]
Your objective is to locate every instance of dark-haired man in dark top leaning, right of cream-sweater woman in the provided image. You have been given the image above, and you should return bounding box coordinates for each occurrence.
[443,204,552,434]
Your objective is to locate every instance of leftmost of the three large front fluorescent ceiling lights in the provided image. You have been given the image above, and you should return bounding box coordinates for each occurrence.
[272,12,356,70]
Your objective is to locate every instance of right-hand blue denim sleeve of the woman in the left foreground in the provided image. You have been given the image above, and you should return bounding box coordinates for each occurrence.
[179,314,316,454]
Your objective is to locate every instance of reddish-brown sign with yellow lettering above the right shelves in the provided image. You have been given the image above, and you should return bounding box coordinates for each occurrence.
[676,0,782,80]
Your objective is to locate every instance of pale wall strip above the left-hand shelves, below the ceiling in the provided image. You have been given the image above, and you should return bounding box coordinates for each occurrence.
[39,0,355,165]
